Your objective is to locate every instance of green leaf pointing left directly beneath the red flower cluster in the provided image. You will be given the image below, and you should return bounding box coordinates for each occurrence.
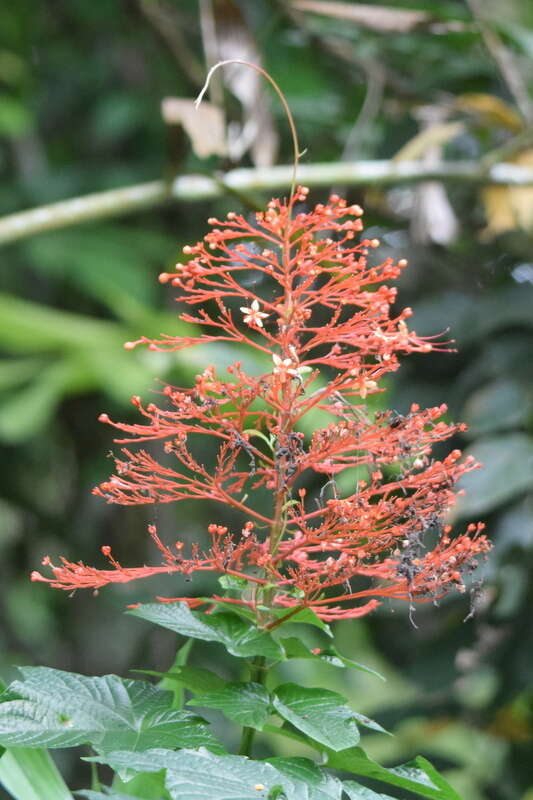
[128,603,283,660]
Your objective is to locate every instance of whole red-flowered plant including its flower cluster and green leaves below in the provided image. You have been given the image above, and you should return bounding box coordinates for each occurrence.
[0,62,489,799]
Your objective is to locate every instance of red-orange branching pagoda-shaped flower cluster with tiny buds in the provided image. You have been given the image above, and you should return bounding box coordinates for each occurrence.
[32,187,490,625]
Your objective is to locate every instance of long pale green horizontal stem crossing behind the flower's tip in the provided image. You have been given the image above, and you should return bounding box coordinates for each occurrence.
[0,160,533,244]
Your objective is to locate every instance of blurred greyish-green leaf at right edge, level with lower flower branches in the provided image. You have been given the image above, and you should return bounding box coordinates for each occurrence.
[456,433,533,518]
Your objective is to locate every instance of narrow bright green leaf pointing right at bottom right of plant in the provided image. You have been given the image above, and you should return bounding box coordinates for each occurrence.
[327,747,461,800]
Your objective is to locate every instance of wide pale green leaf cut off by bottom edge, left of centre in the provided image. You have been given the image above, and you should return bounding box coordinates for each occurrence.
[87,748,310,800]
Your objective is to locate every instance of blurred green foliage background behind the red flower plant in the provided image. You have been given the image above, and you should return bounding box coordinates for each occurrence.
[0,0,533,800]
